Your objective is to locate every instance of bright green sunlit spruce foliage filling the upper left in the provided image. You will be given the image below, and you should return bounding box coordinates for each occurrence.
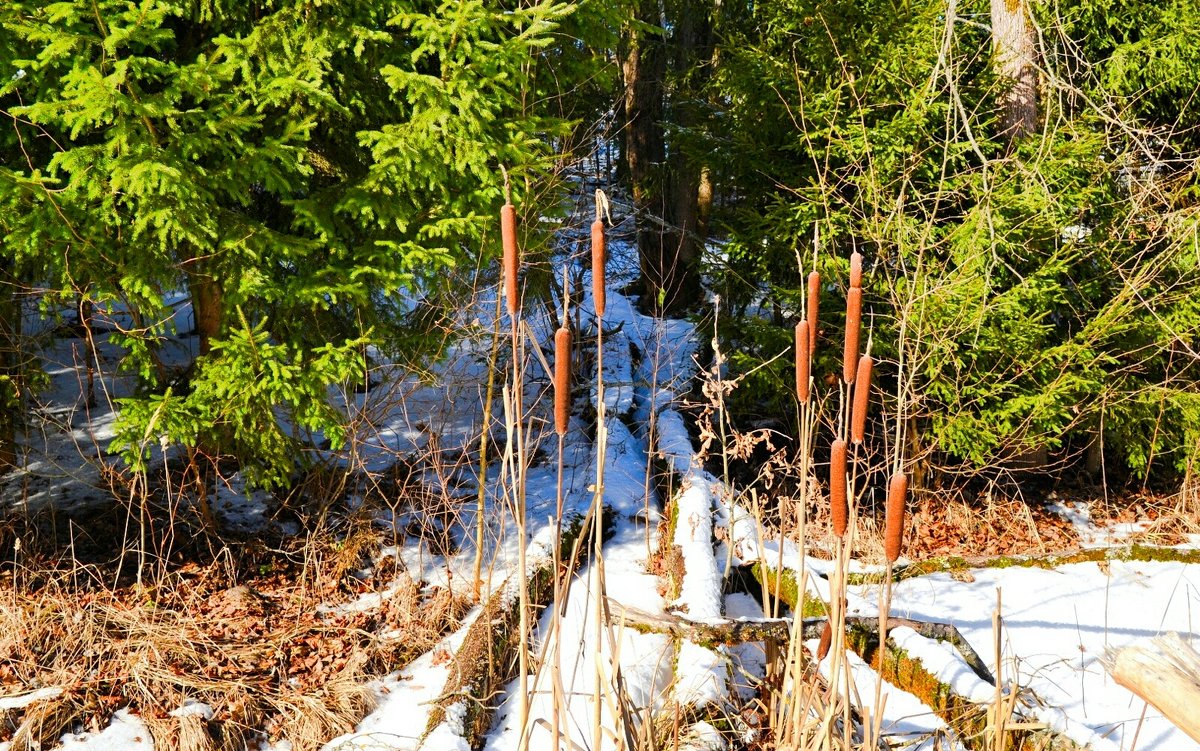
[0,0,571,483]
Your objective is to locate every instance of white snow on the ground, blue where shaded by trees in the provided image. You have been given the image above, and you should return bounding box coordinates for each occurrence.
[0,194,1200,751]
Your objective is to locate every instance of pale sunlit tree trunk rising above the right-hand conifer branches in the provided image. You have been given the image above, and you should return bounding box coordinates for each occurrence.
[991,0,1038,143]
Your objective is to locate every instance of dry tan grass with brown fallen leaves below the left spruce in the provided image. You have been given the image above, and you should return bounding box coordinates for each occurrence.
[0,496,466,751]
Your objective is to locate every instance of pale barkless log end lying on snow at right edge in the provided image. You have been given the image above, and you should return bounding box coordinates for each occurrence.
[1100,633,1200,743]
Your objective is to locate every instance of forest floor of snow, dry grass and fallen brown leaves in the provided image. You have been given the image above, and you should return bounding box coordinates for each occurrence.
[0,182,1200,751]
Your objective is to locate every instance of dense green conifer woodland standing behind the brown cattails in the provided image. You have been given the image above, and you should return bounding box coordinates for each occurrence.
[0,0,1200,488]
